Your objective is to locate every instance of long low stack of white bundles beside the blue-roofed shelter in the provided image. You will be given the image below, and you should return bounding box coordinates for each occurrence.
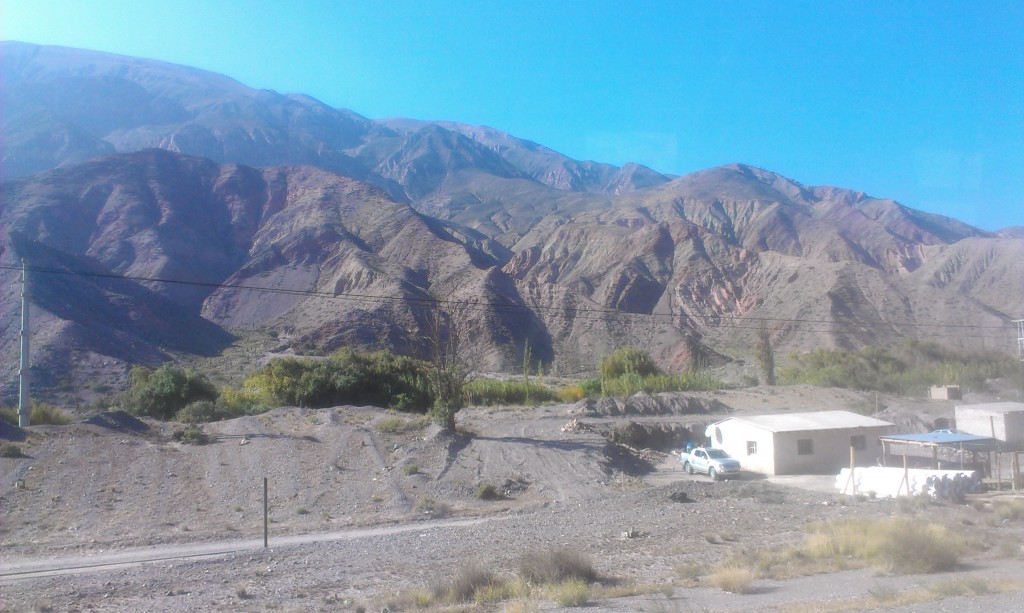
[836,467,981,500]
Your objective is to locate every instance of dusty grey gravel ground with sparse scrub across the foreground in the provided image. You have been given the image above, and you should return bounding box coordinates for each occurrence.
[0,387,1024,611]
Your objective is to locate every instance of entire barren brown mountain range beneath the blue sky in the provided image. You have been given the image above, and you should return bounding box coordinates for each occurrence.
[0,42,1024,399]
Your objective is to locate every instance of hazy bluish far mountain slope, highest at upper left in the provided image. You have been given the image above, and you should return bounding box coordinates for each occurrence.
[0,42,376,186]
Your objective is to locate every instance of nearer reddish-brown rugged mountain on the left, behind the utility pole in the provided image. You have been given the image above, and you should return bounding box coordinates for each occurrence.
[0,149,551,388]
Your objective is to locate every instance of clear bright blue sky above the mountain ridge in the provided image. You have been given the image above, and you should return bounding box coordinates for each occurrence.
[0,0,1024,229]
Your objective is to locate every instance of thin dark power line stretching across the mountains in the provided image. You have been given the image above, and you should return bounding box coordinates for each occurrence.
[0,260,1009,339]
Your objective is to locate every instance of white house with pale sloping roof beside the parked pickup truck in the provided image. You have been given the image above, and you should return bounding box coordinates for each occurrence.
[705,410,893,475]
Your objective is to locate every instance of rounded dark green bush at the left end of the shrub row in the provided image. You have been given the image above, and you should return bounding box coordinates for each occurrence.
[128,366,218,420]
